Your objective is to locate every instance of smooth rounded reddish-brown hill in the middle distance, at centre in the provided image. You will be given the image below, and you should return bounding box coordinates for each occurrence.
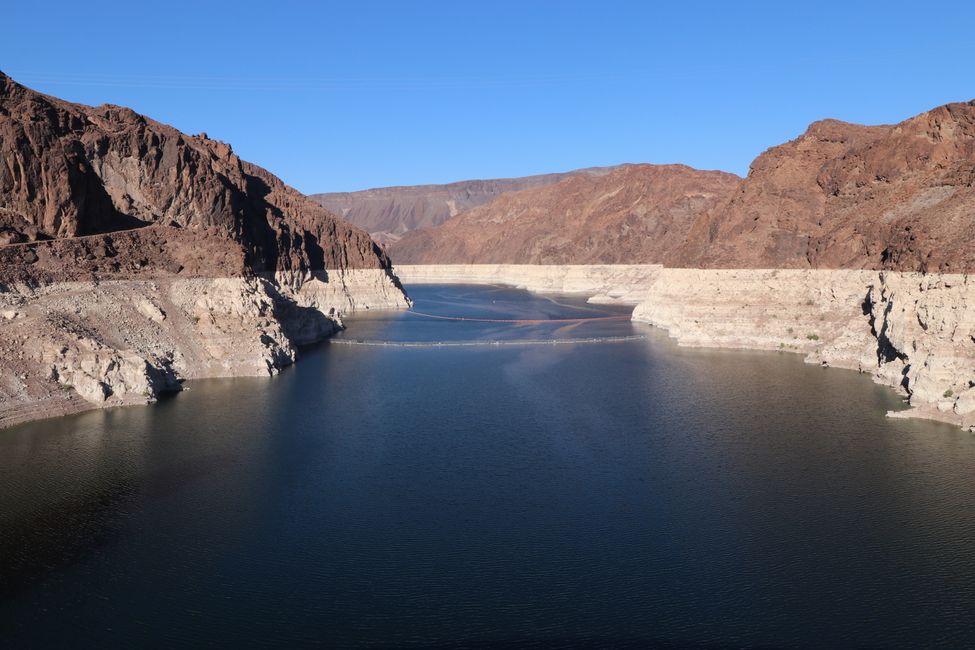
[390,165,741,264]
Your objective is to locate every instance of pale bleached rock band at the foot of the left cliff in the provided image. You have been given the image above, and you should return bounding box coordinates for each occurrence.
[0,269,409,428]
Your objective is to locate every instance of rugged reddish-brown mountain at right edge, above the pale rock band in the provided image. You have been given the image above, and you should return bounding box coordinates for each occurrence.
[679,102,975,272]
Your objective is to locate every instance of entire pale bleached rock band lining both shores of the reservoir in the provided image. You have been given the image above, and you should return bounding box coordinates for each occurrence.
[7,265,975,431]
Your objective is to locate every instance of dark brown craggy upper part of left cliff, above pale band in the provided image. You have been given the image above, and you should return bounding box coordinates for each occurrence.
[0,73,388,274]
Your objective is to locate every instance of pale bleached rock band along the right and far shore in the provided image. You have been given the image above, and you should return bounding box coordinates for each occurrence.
[397,265,975,430]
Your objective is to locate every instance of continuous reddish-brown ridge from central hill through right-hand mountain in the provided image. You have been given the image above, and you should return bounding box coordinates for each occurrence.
[390,101,975,272]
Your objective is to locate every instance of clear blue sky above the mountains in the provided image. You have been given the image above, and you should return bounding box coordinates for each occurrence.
[0,0,975,192]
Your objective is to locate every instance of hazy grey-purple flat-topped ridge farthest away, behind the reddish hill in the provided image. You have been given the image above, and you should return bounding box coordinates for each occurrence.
[311,167,613,243]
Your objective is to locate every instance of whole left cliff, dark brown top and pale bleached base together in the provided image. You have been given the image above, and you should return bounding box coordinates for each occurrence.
[0,74,407,427]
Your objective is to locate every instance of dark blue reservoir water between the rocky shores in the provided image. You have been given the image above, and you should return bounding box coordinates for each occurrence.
[0,287,975,648]
